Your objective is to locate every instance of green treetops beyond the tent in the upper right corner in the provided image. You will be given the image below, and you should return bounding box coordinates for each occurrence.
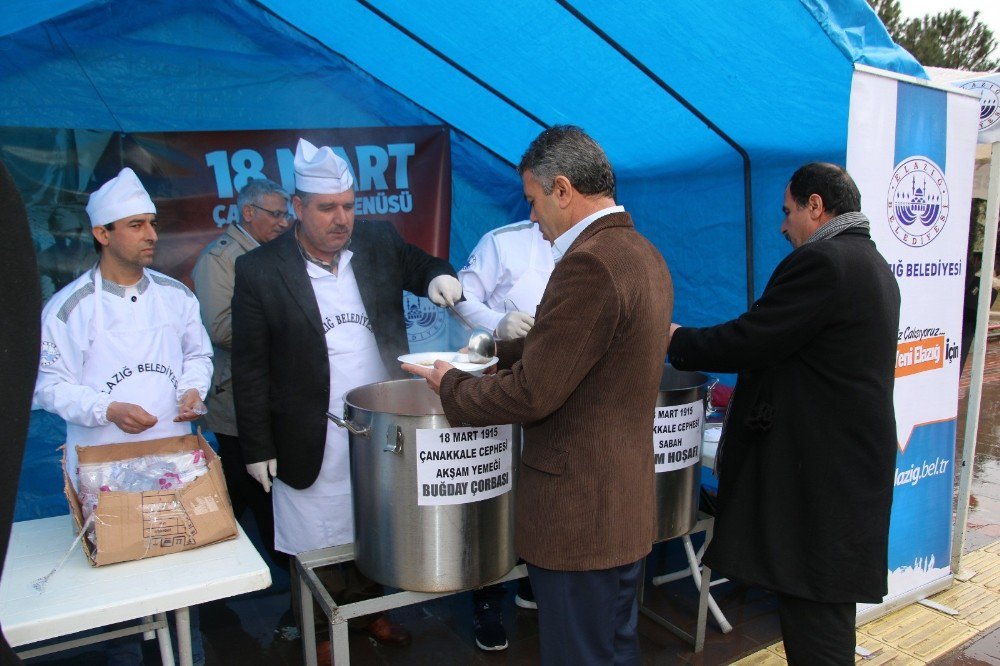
[868,0,1000,72]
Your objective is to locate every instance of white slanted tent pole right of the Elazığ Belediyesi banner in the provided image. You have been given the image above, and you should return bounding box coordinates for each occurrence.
[951,142,1000,574]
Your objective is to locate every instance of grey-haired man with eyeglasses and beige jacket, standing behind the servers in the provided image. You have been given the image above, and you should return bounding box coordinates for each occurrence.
[191,178,294,580]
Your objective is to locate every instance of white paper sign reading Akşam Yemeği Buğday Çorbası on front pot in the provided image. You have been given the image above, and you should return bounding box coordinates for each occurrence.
[417,424,514,506]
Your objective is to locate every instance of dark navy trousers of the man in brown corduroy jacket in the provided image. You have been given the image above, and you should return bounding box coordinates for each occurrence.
[528,560,642,666]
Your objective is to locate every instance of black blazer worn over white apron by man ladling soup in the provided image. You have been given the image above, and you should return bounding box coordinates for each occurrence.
[233,220,455,488]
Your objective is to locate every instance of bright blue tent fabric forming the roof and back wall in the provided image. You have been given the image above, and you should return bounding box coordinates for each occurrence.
[0,0,926,520]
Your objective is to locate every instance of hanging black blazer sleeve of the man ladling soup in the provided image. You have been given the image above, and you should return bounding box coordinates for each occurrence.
[232,255,277,463]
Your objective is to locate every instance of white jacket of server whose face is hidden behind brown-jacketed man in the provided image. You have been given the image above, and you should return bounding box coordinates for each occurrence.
[456,220,554,331]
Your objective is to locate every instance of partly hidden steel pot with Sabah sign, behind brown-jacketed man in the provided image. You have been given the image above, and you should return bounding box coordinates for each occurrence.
[653,365,712,541]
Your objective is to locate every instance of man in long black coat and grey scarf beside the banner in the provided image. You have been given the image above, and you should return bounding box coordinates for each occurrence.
[669,163,899,664]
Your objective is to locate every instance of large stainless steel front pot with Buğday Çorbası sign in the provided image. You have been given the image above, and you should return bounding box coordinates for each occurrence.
[328,379,521,592]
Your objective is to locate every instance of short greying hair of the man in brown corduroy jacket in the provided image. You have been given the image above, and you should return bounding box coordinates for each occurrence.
[517,125,615,199]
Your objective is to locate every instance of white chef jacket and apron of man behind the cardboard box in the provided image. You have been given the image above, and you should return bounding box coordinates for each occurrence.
[32,266,212,483]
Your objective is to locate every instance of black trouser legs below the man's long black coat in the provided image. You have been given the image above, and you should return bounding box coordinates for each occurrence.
[777,594,857,666]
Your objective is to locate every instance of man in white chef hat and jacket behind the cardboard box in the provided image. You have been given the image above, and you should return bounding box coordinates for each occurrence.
[32,168,212,485]
